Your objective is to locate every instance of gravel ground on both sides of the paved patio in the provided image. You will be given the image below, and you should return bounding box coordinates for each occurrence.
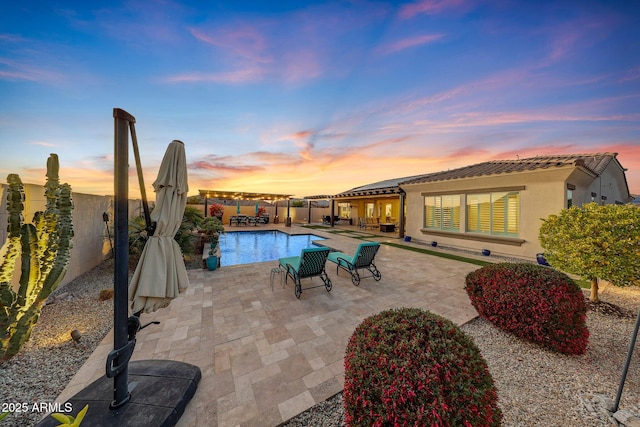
[0,260,640,427]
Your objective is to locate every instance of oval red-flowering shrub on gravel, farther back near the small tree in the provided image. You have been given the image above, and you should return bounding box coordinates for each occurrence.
[465,263,589,354]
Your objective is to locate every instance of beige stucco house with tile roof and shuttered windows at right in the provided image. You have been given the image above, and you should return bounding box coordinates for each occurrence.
[398,153,632,258]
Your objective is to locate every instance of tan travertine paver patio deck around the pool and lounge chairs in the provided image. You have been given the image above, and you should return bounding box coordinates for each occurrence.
[58,226,478,427]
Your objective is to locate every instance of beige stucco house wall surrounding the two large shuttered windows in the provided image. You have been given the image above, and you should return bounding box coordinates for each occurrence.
[400,156,630,259]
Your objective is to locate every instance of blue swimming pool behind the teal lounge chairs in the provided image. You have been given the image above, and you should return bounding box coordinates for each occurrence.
[219,230,325,266]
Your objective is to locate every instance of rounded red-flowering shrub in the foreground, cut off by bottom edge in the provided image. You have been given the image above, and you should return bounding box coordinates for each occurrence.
[344,308,502,427]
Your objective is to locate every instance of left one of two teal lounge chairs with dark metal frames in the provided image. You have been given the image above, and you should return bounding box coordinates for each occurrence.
[278,247,332,299]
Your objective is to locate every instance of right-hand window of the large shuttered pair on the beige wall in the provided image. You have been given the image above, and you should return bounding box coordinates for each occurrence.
[467,192,520,237]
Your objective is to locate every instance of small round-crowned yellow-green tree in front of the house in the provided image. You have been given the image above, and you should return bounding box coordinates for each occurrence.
[539,203,640,302]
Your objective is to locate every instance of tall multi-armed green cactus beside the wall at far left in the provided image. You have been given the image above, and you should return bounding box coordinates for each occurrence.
[0,154,73,360]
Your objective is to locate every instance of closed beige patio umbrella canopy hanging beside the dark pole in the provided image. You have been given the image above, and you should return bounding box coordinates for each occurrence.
[129,140,189,313]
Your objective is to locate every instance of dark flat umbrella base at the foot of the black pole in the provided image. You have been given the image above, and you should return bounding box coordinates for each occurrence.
[37,360,202,427]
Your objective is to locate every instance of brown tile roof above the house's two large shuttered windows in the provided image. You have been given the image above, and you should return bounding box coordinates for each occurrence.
[398,153,618,185]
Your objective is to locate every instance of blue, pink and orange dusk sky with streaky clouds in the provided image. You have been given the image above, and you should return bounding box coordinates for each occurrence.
[0,0,640,199]
